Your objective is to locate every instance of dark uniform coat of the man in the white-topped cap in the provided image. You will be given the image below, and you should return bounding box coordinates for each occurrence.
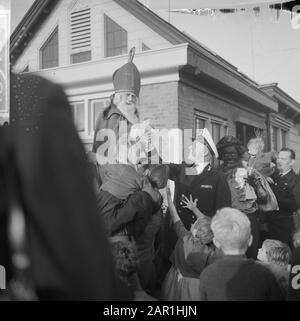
[169,164,231,230]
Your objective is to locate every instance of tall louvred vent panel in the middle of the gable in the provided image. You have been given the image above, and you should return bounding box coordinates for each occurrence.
[70,8,92,64]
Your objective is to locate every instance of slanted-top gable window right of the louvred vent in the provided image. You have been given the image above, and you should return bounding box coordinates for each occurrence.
[104,15,128,57]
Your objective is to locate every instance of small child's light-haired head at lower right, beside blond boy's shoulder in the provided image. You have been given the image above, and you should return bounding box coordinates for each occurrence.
[257,239,292,268]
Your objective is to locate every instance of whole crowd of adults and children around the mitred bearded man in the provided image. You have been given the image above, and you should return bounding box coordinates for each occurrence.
[0,51,300,301]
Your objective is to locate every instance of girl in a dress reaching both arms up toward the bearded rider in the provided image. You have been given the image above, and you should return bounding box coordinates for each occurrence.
[161,188,217,301]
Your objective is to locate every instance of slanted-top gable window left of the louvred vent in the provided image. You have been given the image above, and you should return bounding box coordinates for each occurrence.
[40,27,58,69]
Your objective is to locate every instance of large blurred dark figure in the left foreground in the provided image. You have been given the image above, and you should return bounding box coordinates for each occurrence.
[2,75,130,300]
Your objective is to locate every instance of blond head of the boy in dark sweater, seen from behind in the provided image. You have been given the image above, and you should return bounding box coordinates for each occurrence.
[211,207,252,255]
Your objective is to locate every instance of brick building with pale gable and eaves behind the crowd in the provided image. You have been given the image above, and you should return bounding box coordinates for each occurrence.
[11,0,300,170]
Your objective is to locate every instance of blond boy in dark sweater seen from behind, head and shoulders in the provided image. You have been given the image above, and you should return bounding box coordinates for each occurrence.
[200,208,284,301]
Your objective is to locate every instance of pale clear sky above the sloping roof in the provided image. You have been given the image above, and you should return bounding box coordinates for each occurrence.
[8,0,300,102]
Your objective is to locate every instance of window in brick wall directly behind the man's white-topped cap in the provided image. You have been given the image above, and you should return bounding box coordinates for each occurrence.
[194,112,228,144]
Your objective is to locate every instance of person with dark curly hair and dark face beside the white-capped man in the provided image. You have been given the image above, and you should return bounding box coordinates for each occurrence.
[217,135,259,259]
